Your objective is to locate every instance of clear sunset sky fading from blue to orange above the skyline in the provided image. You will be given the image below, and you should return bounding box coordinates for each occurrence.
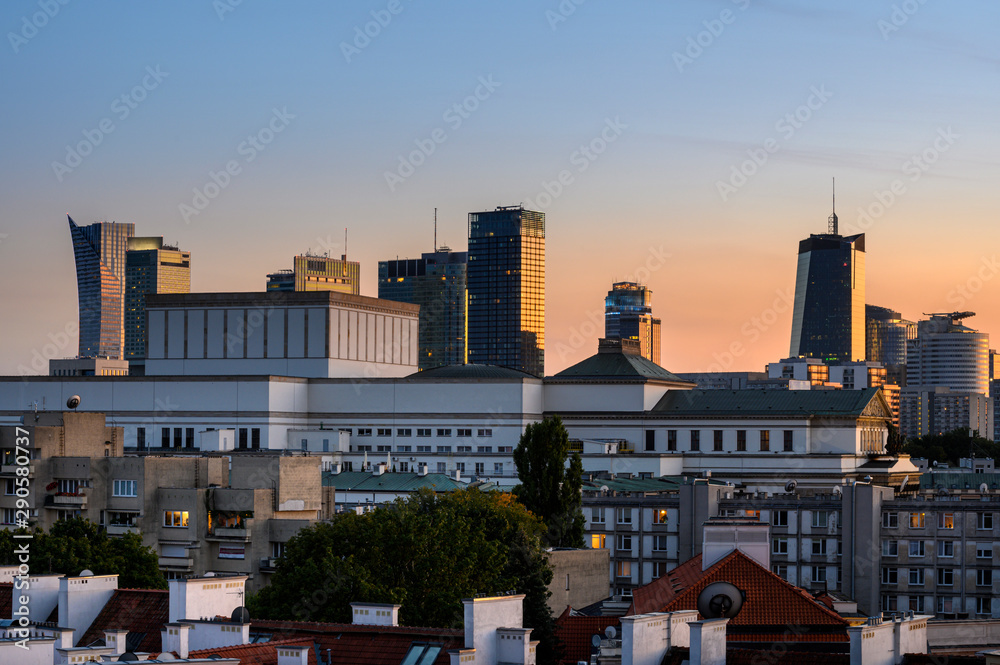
[0,0,1000,375]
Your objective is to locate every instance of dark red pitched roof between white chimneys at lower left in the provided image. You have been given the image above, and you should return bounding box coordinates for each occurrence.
[76,589,170,652]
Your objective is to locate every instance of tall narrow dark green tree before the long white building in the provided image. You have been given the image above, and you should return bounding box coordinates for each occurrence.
[514,416,584,547]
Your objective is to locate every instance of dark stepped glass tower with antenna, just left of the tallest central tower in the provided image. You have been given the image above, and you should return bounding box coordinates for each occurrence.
[378,247,469,369]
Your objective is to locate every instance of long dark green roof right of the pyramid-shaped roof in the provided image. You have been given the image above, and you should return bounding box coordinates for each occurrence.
[652,388,879,416]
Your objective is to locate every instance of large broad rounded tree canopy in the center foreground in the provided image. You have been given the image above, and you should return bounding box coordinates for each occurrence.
[248,488,555,662]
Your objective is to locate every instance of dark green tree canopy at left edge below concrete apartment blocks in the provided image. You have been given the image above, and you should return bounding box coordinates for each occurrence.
[0,517,167,589]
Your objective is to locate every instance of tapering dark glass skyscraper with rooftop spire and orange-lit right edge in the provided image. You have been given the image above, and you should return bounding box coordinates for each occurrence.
[788,197,866,362]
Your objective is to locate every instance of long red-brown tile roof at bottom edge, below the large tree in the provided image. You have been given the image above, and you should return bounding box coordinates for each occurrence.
[250,620,465,665]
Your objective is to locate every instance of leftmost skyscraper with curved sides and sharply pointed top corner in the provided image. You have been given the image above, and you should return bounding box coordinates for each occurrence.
[66,215,135,359]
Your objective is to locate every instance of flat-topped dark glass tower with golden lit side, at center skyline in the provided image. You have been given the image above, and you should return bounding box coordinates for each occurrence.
[468,206,545,376]
